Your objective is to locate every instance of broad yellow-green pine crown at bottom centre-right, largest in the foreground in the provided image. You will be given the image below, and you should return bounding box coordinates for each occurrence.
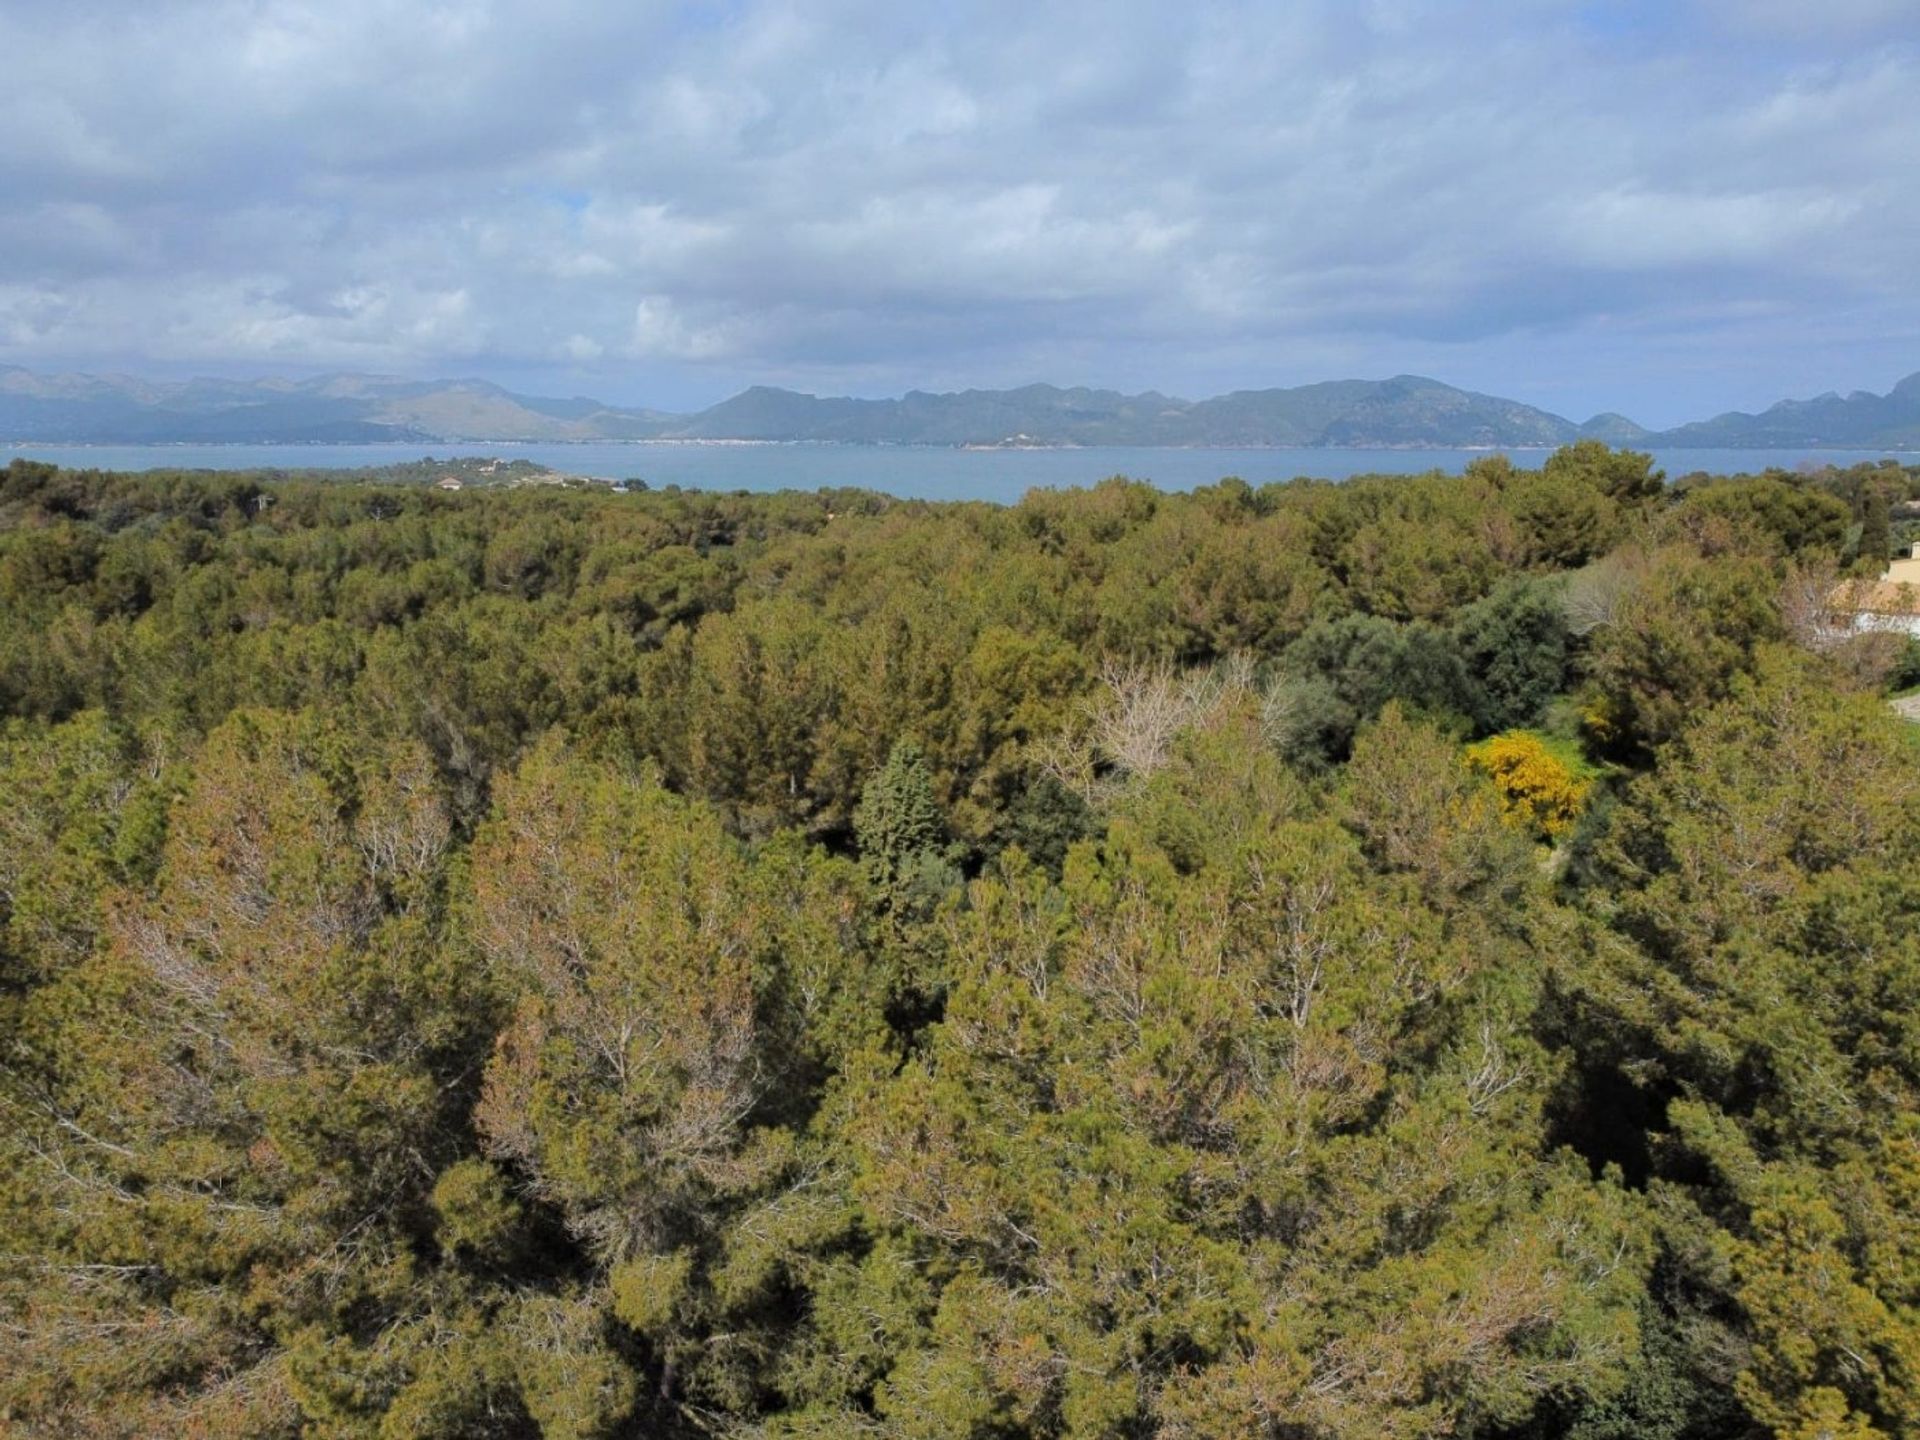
[858,733,1634,1434]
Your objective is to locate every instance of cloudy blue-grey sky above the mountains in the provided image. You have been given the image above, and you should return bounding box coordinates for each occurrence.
[0,0,1920,426]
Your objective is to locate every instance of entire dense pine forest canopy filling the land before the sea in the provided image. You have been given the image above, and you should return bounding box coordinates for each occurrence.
[0,453,1920,1440]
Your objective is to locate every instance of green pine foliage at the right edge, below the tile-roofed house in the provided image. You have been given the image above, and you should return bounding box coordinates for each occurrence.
[1580,653,1920,1434]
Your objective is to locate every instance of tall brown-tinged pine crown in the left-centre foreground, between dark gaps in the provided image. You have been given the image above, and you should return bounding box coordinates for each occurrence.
[468,741,766,1261]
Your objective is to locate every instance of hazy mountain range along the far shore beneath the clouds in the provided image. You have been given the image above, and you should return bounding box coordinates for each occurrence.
[0,367,1920,449]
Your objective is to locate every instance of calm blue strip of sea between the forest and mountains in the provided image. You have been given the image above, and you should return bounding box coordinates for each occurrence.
[0,444,1904,503]
